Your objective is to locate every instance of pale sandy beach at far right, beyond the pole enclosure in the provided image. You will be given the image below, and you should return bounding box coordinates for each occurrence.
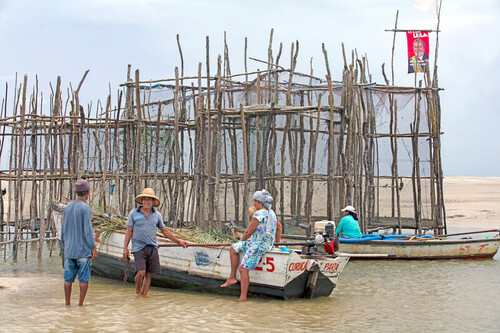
[444,177,500,229]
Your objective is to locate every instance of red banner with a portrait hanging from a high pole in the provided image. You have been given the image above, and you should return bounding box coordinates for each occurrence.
[406,31,429,73]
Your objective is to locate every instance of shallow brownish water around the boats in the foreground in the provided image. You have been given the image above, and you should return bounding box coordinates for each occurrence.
[0,239,500,332]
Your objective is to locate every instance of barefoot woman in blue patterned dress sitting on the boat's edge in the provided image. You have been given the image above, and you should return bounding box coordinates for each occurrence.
[221,190,282,302]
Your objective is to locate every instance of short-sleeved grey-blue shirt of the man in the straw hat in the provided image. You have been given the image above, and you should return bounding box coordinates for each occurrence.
[127,206,165,253]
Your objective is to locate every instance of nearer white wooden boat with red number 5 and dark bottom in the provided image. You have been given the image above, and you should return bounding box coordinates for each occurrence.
[49,212,349,300]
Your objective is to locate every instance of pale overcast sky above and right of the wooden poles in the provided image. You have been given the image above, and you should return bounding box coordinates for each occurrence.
[0,0,500,176]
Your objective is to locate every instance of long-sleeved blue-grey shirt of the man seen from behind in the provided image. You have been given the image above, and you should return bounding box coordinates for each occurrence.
[61,200,95,259]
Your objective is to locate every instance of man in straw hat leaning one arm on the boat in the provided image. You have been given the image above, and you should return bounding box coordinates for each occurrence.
[123,188,187,297]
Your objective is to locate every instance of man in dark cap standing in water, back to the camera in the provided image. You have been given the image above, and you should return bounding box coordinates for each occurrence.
[61,180,97,306]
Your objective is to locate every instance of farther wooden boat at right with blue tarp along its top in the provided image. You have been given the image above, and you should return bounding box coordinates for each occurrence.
[340,235,500,259]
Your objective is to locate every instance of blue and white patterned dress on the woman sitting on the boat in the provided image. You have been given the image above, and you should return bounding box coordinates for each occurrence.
[232,209,277,270]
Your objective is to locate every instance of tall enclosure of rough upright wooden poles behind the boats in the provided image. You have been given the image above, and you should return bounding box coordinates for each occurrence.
[0,33,445,256]
